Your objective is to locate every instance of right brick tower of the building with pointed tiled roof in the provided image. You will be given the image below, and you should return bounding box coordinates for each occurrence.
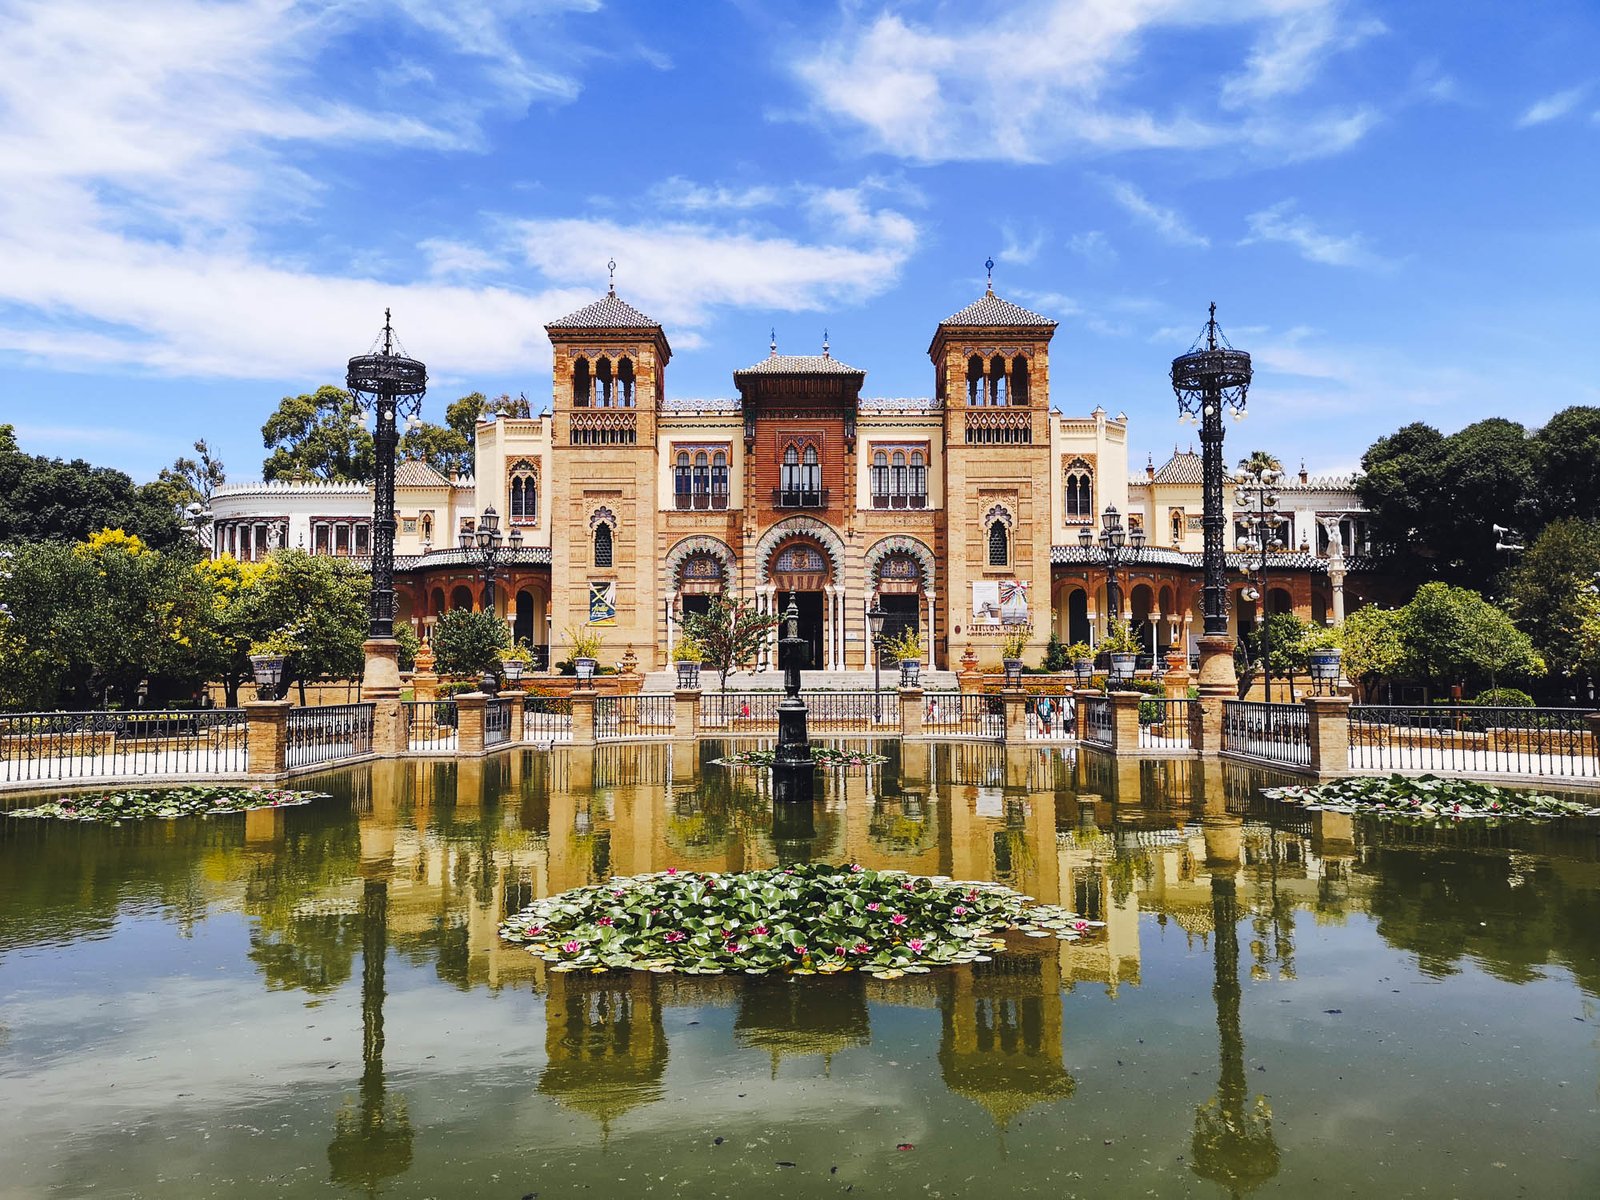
[928,259,1056,662]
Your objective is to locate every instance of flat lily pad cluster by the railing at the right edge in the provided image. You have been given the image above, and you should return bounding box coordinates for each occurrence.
[1262,774,1600,824]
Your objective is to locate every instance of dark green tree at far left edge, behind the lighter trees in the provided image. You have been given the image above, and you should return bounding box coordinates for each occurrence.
[0,426,182,549]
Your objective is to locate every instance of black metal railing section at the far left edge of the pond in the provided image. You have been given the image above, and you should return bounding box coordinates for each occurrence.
[0,709,246,782]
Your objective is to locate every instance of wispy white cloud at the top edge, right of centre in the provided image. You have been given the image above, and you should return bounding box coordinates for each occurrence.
[794,0,1381,162]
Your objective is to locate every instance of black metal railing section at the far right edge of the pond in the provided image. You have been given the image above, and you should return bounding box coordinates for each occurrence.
[1350,704,1600,779]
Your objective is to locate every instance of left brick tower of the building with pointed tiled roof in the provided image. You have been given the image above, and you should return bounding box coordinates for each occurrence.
[544,276,672,669]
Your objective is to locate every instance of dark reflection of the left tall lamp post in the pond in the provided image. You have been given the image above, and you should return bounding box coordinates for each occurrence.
[328,880,411,1195]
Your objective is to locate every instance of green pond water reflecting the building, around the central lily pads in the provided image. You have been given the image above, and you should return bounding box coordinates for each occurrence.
[0,746,1600,1200]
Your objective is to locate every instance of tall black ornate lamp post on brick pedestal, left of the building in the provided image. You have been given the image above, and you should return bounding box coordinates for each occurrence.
[344,309,427,752]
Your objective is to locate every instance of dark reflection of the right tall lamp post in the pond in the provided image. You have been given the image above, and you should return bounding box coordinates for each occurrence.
[1190,872,1278,1195]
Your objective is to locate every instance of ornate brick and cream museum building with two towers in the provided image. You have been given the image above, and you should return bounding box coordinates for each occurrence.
[211,288,1373,670]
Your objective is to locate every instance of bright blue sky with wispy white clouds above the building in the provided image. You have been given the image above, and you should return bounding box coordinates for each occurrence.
[0,0,1600,480]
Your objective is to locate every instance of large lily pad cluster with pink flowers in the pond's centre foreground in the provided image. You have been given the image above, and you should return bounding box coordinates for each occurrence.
[501,862,1102,979]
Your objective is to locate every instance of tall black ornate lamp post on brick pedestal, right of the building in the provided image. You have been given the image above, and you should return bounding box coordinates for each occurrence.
[1171,304,1251,696]
